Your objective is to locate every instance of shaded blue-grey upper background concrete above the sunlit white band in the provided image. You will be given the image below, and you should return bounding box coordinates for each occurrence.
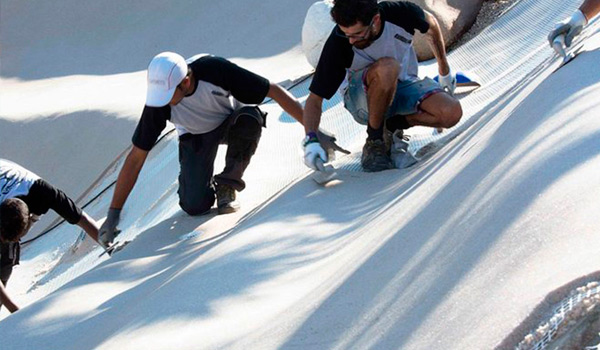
[0,0,313,80]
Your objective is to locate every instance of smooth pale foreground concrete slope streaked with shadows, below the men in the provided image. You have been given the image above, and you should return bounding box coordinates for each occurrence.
[0,28,600,350]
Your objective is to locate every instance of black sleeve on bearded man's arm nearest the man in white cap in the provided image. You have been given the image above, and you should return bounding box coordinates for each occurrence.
[309,28,354,100]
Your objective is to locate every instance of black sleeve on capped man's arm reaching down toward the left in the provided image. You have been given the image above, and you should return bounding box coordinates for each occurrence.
[131,105,171,151]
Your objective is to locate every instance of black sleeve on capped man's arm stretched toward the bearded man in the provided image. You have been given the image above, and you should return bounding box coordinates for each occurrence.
[190,56,270,104]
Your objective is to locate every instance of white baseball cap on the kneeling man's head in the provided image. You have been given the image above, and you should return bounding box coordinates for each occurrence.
[146,52,188,107]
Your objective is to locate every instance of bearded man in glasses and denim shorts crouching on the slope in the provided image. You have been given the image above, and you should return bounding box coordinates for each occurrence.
[303,0,462,172]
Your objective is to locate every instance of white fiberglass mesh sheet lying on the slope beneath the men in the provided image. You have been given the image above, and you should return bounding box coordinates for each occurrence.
[23,0,580,306]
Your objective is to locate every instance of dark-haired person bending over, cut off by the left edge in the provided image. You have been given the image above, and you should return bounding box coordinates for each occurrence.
[0,158,98,312]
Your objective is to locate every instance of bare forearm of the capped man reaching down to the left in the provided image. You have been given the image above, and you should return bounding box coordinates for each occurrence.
[110,146,148,209]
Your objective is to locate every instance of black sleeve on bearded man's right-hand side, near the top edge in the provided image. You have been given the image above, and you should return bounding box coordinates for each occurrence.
[379,1,429,35]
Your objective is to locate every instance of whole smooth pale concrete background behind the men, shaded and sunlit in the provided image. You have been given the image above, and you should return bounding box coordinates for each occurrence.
[0,0,313,235]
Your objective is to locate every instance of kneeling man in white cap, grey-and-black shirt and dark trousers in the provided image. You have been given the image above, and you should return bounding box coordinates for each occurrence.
[99,52,347,244]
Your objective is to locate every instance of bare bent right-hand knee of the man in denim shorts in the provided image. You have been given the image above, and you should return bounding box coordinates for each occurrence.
[406,92,462,128]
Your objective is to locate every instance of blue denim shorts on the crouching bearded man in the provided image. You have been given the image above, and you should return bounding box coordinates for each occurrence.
[344,67,444,125]
